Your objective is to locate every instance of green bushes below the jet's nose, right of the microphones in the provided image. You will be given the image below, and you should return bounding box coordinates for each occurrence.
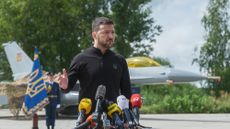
[141,84,226,113]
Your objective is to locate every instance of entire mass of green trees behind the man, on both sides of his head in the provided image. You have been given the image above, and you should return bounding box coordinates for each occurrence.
[0,0,161,80]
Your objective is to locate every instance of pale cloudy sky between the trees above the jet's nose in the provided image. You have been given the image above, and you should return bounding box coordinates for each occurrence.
[148,0,208,73]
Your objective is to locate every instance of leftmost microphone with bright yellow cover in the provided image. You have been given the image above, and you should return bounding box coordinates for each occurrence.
[76,98,92,125]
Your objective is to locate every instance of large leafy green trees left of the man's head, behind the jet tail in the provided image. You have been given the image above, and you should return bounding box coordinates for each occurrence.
[1,0,108,72]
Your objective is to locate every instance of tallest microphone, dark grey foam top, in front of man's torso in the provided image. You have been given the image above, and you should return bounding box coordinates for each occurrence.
[92,85,106,126]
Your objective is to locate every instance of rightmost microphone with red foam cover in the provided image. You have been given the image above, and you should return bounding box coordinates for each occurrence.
[131,94,142,122]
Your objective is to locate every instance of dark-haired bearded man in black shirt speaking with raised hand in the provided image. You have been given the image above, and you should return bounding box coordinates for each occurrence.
[59,17,131,105]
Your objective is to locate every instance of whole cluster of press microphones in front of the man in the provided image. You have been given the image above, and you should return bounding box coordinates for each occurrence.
[75,85,145,129]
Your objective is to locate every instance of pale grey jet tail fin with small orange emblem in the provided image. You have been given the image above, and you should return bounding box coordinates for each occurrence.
[3,42,33,80]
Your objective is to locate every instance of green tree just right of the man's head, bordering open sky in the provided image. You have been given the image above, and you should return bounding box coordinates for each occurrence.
[111,0,162,57]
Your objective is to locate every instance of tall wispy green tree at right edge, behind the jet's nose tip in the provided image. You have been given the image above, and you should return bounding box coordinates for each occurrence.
[194,0,230,91]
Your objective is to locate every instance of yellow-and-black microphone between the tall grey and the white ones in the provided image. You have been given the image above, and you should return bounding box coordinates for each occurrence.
[107,102,124,129]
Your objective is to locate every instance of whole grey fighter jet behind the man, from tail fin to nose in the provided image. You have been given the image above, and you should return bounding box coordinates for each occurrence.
[3,42,220,114]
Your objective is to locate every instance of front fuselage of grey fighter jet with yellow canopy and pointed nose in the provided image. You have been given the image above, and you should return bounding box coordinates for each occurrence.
[126,57,220,84]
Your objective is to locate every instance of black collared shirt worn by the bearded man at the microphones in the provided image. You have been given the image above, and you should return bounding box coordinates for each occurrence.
[62,47,131,102]
